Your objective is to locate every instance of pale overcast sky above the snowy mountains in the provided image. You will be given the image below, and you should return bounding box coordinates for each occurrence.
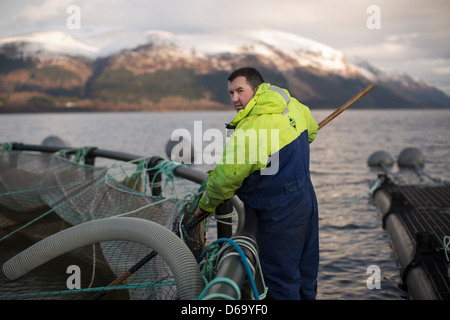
[0,0,450,95]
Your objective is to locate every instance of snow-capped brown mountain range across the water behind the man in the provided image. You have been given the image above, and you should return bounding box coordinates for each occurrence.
[0,30,450,110]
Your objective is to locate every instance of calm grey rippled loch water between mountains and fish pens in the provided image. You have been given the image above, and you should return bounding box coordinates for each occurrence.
[0,110,450,299]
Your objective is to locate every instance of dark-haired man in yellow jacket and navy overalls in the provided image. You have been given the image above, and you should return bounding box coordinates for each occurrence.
[196,68,319,300]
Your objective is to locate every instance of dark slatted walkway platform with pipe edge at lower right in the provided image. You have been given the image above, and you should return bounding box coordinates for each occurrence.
[373,175,450,300]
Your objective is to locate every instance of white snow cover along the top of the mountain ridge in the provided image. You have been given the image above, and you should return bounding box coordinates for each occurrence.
[0,30,348,71]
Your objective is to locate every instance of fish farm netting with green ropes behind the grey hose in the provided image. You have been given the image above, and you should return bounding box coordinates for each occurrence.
[0,147,205,300]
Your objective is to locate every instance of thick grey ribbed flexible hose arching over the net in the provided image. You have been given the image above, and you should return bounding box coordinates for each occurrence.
[3,217,204,300]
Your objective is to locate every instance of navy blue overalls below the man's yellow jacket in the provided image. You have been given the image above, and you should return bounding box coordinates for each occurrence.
[236,130,319,300]
